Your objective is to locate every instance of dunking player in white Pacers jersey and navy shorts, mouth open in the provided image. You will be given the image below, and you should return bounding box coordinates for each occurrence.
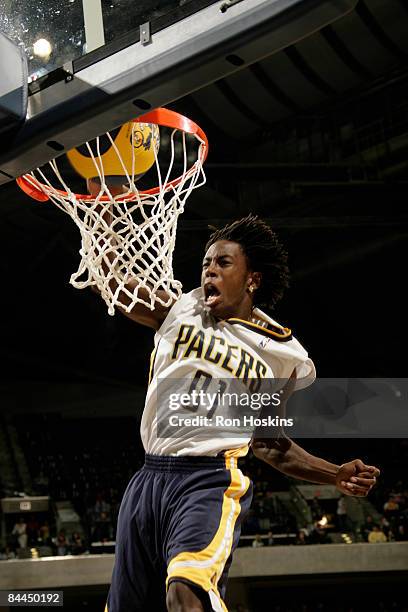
[93,208,379,612]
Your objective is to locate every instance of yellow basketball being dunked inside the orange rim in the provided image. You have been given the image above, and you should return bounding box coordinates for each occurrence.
[67,121,160,180]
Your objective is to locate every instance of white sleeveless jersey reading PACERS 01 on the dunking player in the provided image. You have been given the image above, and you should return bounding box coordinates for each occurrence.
[141,288,316,456]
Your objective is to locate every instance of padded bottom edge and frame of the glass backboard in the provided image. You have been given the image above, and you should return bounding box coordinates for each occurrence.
[0,0,356,184]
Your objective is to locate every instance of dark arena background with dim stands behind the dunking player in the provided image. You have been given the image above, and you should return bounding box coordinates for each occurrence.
[0,0,408,612]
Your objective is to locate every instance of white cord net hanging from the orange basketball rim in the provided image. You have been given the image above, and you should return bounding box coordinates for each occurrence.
[18,112,207,315]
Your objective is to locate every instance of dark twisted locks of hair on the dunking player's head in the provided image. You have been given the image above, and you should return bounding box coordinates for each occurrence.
[205,214,289,309]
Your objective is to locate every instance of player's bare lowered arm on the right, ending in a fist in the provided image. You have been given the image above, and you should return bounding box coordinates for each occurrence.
[251,370,380,497]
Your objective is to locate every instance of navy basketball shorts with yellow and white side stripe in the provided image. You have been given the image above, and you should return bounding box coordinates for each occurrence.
[107,449,252,612]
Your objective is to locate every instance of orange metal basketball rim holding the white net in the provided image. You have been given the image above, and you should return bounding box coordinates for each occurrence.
[16,108,208,202]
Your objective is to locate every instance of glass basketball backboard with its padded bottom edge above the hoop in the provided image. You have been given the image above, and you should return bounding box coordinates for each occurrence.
[0,0,357,184]
